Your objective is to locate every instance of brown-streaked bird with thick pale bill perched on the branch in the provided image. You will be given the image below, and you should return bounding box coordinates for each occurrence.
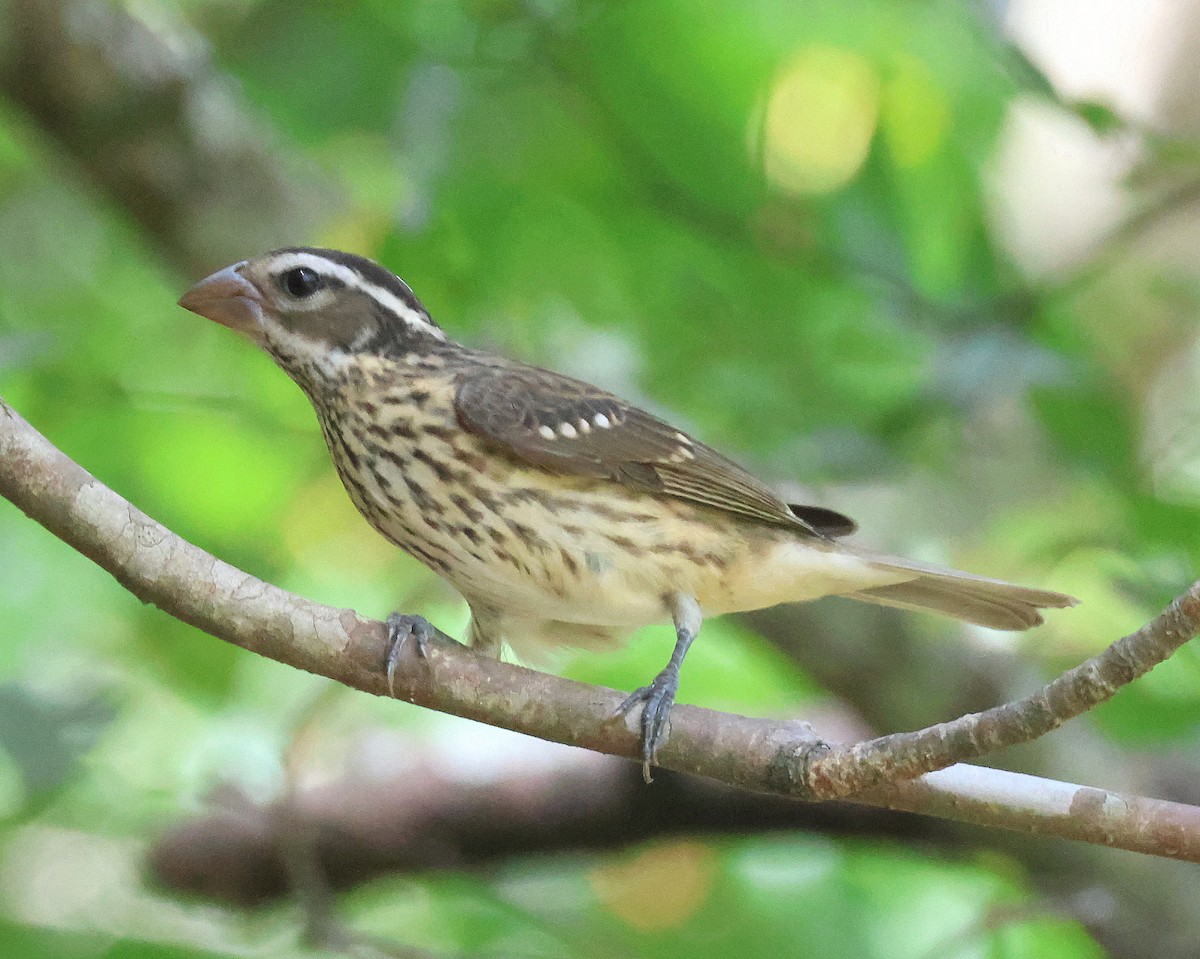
[179,246,1076,781]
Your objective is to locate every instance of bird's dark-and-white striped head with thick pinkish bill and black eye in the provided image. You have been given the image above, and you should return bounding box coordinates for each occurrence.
[179,247,445,368]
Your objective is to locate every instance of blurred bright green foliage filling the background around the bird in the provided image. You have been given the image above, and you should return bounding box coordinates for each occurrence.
[0,0,1200,959]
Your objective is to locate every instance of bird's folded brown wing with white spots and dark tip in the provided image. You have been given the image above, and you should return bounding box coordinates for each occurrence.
[455,365,854,537]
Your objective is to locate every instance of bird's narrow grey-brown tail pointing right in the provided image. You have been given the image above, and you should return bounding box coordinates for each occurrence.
[845,550,1079,629]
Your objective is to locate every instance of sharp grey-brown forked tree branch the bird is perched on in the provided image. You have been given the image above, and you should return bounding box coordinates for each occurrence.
[0,391,1200,862]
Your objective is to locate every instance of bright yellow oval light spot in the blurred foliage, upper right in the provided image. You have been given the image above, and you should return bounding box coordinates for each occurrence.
[761,46,880,193]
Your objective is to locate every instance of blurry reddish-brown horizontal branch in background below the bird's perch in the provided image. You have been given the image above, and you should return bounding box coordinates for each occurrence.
[150,738,931,906]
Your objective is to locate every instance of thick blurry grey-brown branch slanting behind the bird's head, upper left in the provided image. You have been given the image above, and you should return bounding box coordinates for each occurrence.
[0,0,341,275]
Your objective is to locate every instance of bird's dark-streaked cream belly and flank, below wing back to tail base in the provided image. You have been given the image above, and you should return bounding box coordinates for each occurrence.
[324,420,897,631]
